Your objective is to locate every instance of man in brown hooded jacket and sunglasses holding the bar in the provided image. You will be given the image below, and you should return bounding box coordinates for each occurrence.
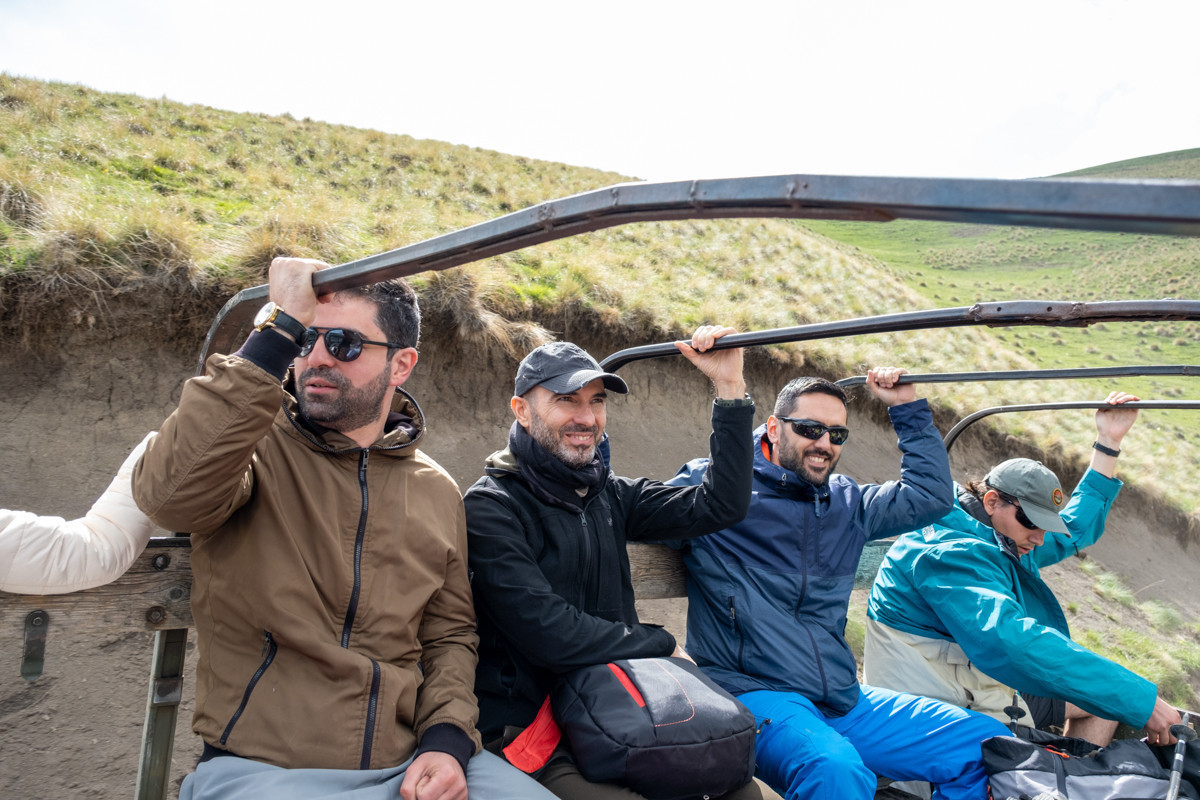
[133,259,550,800]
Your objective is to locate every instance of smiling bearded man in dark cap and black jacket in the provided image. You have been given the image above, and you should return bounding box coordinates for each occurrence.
[464,325,777,800]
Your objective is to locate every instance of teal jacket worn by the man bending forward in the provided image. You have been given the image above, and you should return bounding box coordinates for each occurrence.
[868,470,1158,728]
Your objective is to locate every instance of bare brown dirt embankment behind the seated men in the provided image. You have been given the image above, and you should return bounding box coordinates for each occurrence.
[0,296,1200,800]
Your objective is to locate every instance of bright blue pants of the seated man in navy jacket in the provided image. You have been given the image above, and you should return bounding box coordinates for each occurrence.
[738,686,1009,800]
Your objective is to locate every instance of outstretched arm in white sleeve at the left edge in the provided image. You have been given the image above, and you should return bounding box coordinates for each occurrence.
[0,432,156,595]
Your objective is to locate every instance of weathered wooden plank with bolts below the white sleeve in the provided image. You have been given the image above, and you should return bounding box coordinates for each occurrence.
[0,537,192,642]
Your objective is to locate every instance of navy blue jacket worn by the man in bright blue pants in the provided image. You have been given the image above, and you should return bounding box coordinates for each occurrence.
[671,399,954,715]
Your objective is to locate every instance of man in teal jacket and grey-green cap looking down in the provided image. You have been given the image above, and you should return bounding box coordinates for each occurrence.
[864,392,1180,745]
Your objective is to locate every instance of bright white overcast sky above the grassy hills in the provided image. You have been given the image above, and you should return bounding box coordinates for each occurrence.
[0,0,1200,180]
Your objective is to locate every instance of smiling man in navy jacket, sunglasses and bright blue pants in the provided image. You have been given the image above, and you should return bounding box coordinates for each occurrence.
[672,367,1008,800]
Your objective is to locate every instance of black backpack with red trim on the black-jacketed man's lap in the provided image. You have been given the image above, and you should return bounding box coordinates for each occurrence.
[551,658,755,800]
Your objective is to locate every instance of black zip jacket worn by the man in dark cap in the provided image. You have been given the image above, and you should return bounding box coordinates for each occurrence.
[464,403,754,741]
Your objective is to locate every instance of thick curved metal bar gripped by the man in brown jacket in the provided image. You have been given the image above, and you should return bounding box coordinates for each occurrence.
[199,175,1200,369]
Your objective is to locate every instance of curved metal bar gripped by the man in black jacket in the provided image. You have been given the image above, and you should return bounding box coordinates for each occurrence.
[600,300,1200,372]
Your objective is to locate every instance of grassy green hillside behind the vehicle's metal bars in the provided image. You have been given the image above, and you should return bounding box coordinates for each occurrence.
[0,74,1200,510]
